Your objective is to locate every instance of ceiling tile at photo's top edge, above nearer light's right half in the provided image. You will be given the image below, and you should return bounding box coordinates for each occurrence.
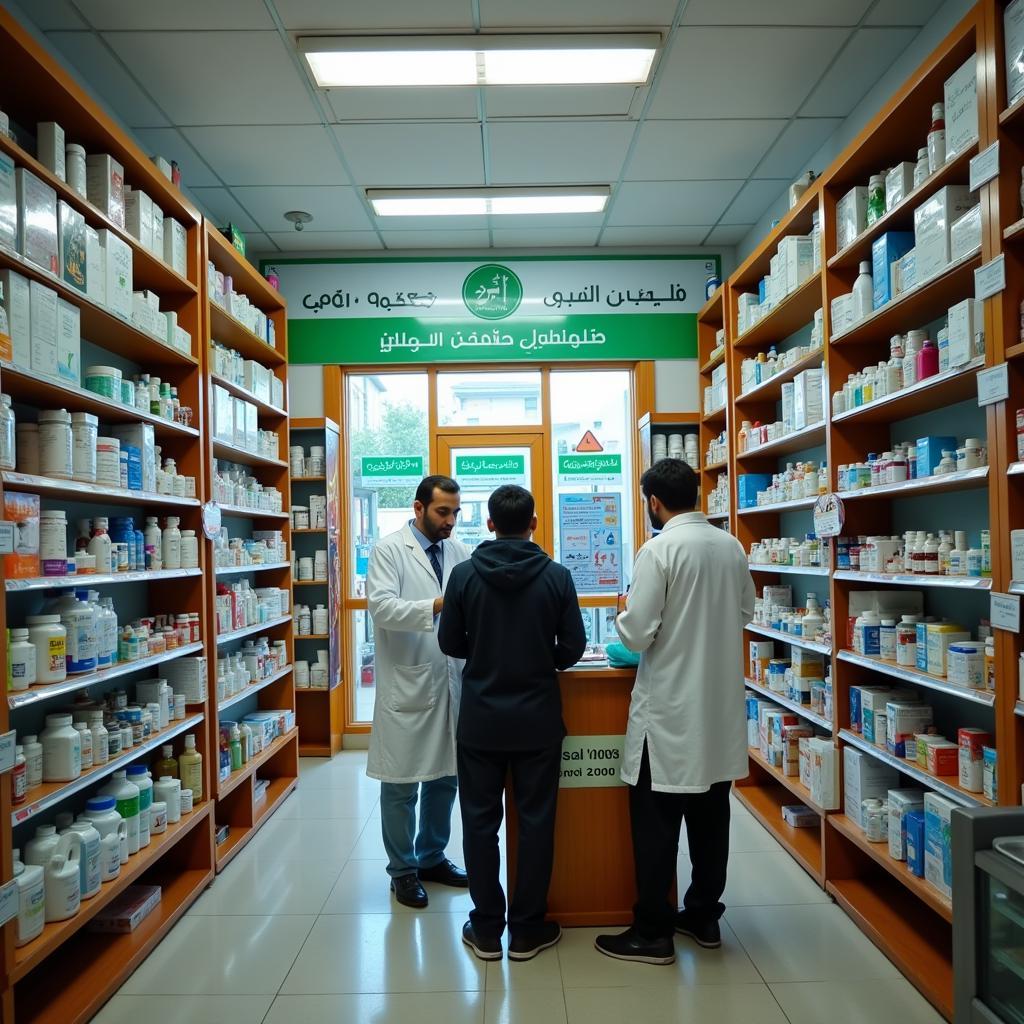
[480,0,676,32]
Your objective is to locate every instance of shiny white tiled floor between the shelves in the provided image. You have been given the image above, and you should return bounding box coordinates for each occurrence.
[90,752,941,1024]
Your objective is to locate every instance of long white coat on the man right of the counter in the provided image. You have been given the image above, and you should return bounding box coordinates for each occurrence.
[616,512,754,793]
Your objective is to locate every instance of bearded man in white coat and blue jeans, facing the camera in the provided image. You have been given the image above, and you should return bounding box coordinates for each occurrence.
[367,476,469,907]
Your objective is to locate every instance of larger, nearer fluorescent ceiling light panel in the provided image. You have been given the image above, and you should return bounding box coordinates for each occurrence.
[298,33,662,89]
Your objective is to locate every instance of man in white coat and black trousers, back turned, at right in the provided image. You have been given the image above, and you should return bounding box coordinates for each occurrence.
[596,459,754,964]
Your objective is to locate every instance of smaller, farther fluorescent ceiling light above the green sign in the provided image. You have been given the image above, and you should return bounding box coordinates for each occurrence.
[367,185,611,217]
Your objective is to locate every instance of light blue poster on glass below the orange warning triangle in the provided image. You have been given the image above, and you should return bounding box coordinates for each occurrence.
[558,495,623,594]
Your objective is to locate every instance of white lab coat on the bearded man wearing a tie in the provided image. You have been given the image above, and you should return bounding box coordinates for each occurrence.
[367,524,469,782]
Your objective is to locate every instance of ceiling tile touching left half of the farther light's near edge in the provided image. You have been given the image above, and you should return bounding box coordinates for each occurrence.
[334,124,483,188]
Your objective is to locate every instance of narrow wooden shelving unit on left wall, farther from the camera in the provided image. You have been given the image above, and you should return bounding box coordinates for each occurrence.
[202,223,299,871]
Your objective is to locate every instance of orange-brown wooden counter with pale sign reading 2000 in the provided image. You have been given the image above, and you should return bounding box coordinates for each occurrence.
[507,667,636,927]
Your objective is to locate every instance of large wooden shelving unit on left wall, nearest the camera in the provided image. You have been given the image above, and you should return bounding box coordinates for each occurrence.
[0,9,214,1024]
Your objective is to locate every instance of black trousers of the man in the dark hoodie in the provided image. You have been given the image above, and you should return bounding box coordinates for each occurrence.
[458,742,562,939]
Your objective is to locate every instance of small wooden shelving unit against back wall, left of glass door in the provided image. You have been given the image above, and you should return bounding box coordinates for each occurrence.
[292,399,345,758]
